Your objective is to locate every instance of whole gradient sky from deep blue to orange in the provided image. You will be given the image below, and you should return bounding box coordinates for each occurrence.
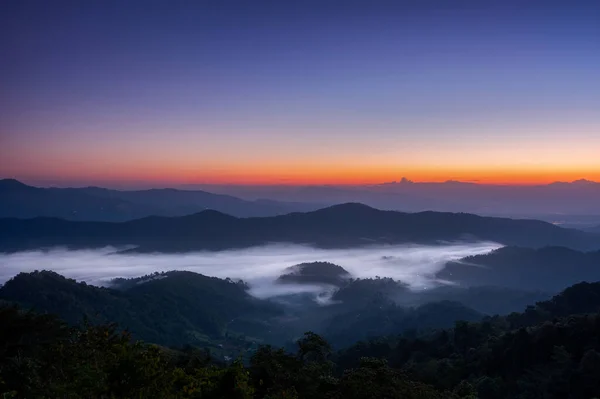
[0,0,600,185]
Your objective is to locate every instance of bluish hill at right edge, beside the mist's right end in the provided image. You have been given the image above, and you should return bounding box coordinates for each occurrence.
[438,247,600,292]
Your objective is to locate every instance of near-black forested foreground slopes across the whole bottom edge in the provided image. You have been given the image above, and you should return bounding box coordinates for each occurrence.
[0,278,600,399]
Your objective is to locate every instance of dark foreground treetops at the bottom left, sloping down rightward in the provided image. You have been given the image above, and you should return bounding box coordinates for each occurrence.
[0,307,454,399]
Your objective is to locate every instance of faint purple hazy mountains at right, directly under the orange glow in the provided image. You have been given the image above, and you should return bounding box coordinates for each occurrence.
[189,179,600,222]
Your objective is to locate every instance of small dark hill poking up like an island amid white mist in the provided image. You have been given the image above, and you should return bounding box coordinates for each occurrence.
[277,262,350,287]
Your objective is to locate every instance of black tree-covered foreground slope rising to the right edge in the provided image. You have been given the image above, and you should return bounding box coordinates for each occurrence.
[335,283,600,399]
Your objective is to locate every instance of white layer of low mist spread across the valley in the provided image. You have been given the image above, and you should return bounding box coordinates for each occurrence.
[0,242,501,298]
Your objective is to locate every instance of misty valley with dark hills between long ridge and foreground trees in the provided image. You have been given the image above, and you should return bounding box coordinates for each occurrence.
[0,234,600,346]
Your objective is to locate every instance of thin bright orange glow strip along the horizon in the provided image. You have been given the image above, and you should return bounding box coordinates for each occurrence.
[14,168,600,187]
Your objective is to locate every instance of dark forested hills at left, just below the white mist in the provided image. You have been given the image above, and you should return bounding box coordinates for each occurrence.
[0,271,281,345]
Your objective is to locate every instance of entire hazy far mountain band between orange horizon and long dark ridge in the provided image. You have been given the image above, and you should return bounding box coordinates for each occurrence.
[0,179,600,229]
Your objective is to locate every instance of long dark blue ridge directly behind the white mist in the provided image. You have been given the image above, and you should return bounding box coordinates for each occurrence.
[0,204,600,252]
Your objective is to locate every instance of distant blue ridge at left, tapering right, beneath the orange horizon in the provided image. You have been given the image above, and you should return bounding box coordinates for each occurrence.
[0,179,318,222]
